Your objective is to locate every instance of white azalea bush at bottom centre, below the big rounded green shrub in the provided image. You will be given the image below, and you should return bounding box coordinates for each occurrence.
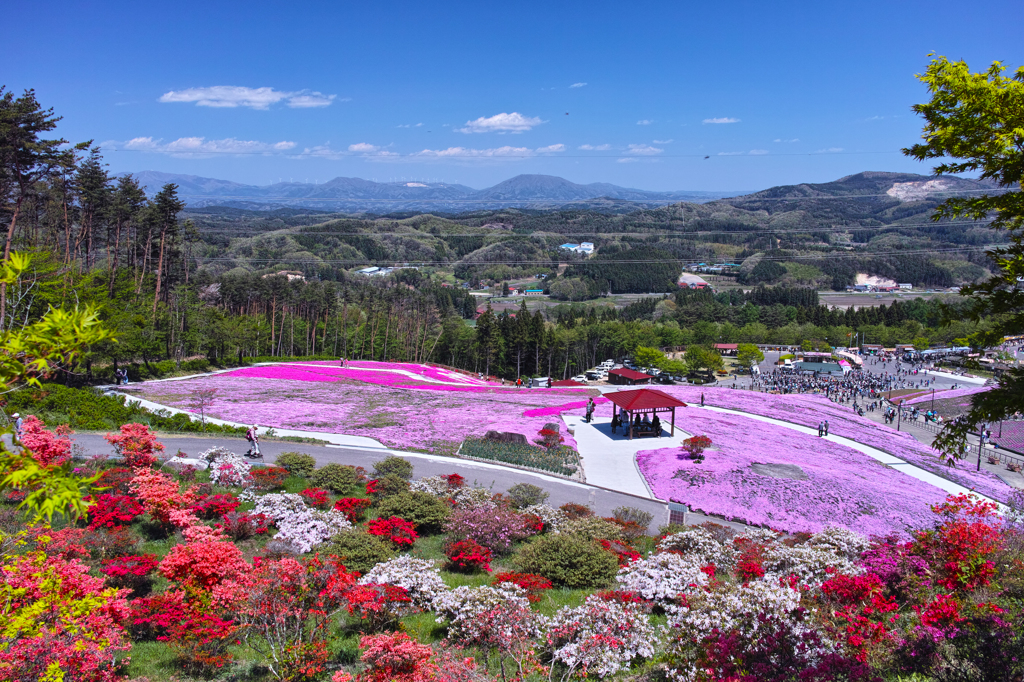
[546,595,658,678]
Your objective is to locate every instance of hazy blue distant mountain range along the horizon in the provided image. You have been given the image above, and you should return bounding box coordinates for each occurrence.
[133,171,743,213]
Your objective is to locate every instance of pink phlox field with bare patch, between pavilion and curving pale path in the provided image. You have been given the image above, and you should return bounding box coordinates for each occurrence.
[637,405,945,536]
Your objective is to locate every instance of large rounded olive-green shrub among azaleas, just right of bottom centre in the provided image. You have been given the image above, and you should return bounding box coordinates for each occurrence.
[512,535,618,590]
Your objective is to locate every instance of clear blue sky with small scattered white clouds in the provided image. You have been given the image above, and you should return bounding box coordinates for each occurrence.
[9,0,1024,190]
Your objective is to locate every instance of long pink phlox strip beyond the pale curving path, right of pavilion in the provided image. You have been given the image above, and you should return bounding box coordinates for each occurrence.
[659,386,1013,502]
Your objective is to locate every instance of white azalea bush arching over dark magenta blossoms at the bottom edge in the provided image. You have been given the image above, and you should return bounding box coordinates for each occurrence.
[666,580,836,682]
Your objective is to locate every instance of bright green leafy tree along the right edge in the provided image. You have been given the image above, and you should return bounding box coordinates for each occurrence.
[903,56,1024,465]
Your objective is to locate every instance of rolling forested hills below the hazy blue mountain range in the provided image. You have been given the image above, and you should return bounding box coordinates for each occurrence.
[185,167,1000,298]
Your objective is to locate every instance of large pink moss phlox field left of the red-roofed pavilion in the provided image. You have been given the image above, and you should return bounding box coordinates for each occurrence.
[131,363,587,452]
